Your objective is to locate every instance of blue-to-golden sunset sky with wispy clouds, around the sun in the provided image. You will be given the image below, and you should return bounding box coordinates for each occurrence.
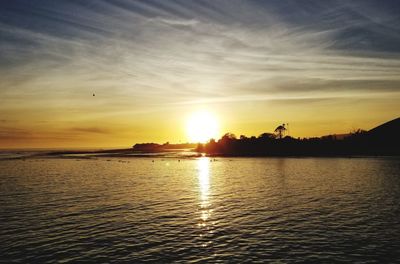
[0,0,400,148]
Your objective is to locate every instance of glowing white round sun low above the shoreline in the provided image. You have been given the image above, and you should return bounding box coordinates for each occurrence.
[186,111,219,143]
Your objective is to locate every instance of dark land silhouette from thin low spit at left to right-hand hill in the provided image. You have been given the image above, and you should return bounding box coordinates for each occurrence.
[39,118,400,157]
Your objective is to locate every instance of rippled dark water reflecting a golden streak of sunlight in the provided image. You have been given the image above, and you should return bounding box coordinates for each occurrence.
[0,158,400,263]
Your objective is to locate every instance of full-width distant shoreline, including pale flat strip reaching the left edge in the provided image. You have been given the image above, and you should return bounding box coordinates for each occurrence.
[0,118,400,160]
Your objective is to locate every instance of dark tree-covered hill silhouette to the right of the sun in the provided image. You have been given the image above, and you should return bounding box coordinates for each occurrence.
[197,118,400,156]
